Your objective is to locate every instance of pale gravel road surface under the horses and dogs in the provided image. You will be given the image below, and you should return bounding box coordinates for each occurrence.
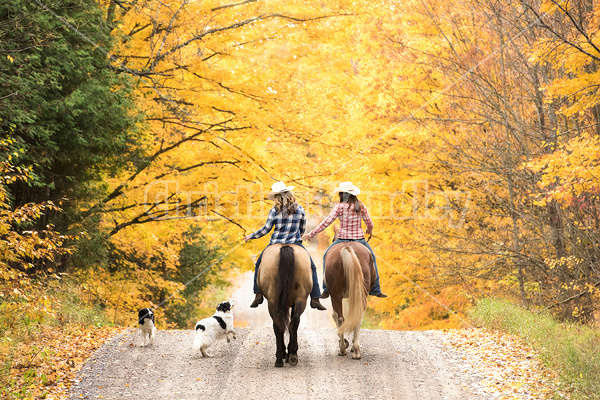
[71,242,486,400]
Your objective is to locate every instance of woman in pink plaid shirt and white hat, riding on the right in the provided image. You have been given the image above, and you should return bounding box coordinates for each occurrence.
[302,182,387,299]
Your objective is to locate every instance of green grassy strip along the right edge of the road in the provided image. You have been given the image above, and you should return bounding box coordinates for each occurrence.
[469,299,600,400]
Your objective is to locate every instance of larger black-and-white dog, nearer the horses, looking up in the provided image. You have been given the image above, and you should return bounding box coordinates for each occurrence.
[192,300,235,357]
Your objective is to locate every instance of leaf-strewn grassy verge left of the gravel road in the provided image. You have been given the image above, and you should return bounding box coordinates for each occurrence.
[0,276,112,399]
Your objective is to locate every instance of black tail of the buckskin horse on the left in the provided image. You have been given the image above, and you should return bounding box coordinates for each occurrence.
[273,246,296,332]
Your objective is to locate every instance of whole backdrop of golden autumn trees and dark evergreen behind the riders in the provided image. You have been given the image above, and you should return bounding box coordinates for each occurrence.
[0,0,600,329]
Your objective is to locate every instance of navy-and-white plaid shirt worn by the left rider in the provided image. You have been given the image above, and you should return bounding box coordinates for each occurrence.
[250,205,306,244]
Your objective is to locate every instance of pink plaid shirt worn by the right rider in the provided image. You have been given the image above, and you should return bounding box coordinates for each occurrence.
[307,203,373,239]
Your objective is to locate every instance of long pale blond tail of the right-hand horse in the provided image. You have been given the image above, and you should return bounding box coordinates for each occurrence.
[338,246,367,333]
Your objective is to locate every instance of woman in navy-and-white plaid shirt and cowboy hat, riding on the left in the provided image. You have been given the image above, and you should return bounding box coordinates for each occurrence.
[244,182,325,310]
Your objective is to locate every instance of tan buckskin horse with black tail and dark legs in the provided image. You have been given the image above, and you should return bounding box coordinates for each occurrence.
[256,244,312,367]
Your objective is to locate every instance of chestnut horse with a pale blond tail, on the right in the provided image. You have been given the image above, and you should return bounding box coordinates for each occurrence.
[323,242,375,360]
